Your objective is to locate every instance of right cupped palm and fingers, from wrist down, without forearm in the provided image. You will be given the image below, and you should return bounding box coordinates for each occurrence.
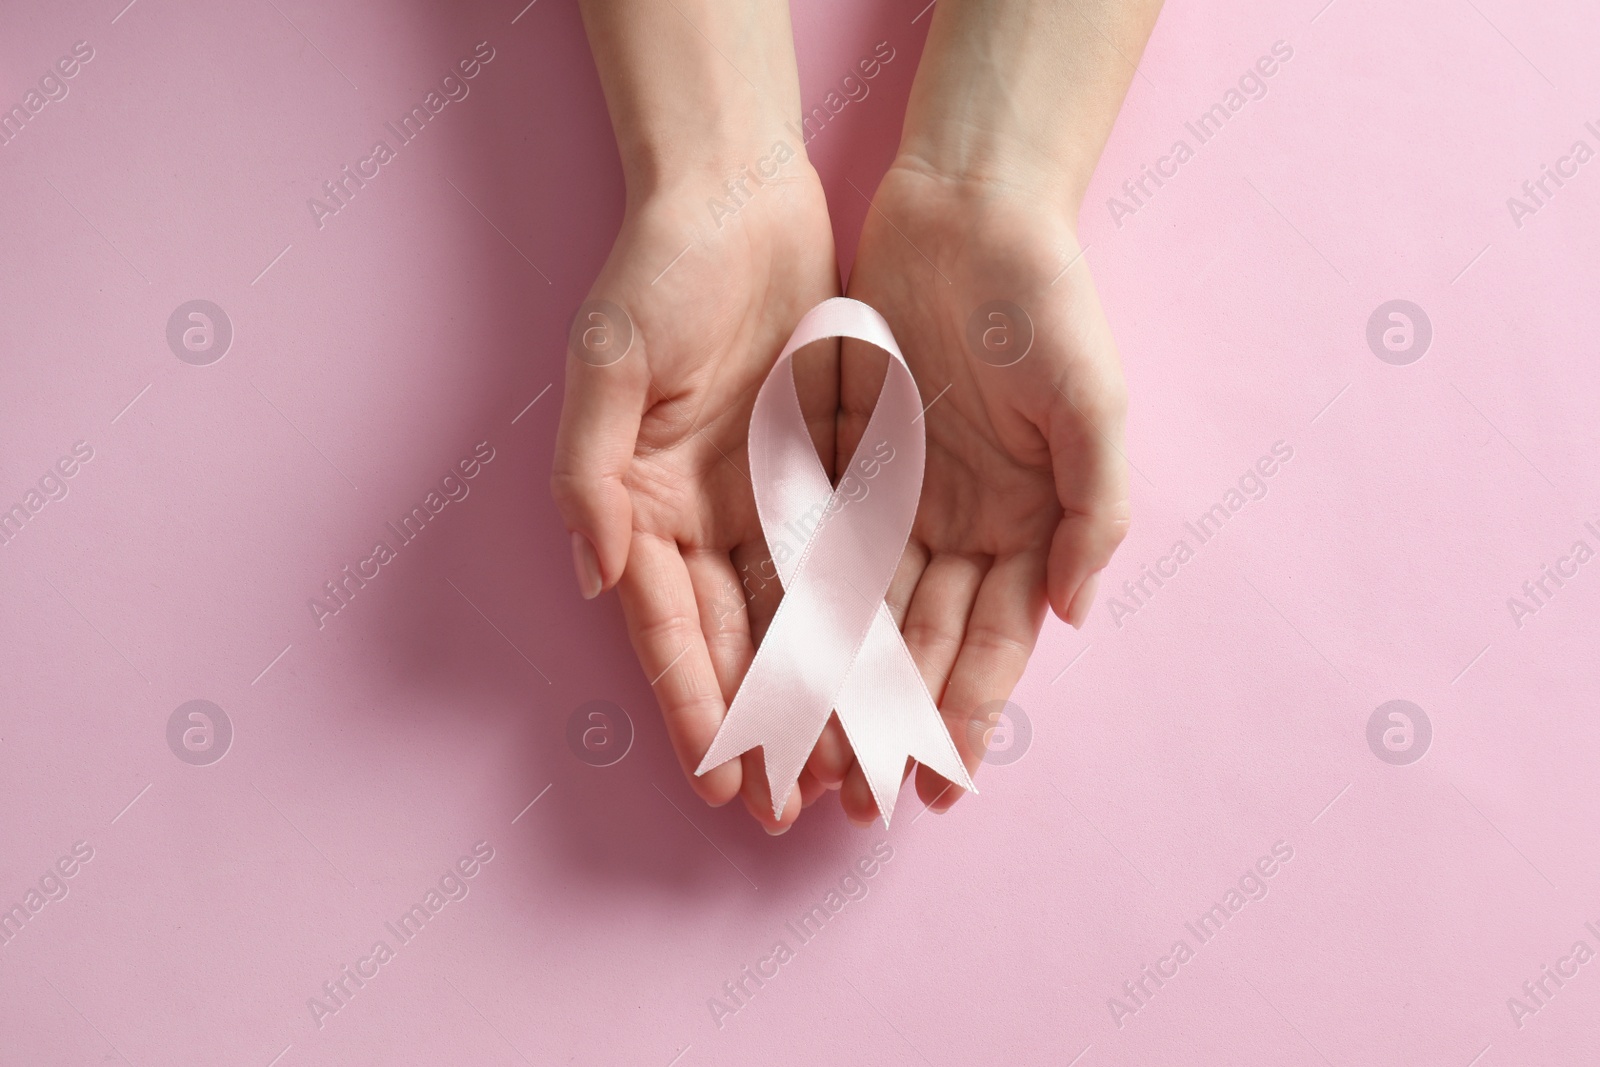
[808,155,1130,822]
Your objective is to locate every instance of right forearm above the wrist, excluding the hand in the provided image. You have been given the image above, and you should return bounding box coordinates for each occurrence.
[901,0,1162,219]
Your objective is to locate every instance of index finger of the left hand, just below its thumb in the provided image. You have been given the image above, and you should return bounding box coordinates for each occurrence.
[618,533,742,806]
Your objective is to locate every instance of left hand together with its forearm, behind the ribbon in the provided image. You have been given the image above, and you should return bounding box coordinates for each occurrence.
[552,0,838,832]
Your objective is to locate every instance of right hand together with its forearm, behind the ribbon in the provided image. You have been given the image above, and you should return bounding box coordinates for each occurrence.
[810,0,1162,822]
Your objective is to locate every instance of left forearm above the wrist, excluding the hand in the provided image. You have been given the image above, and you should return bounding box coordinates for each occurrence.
[581,0,803,198]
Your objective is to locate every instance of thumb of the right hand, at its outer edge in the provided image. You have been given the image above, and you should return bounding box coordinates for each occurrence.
[1046,384,1131,627]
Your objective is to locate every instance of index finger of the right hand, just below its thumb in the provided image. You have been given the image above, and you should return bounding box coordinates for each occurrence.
[917,552,1046,811]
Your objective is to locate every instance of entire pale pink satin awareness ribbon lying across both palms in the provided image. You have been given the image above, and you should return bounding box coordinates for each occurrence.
[694,296,976,825]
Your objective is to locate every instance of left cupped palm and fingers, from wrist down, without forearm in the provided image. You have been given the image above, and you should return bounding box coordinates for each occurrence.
[552,158,838,832]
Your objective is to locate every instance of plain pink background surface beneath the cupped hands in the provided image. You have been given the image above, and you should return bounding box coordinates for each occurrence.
[0,0,1600,1067]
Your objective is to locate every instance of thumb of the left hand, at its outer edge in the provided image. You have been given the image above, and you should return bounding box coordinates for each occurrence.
[550,315,650,598]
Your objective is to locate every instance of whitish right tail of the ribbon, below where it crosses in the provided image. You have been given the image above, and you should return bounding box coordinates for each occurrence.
[838,611,978,827]
